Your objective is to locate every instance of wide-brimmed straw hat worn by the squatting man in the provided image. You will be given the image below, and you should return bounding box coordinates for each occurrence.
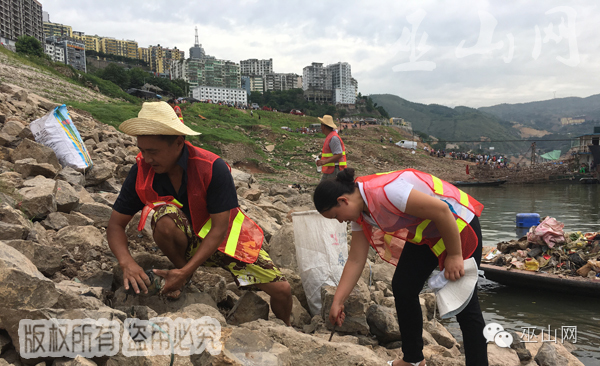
[119,102,201,136]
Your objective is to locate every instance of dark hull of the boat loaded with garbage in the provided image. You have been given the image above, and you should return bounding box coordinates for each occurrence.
[480,263,600,298]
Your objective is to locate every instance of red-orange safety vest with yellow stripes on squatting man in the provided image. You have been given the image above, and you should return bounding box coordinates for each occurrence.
[135,141,264,263]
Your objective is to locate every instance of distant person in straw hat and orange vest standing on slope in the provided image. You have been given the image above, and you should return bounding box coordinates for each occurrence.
[317,114,346,180]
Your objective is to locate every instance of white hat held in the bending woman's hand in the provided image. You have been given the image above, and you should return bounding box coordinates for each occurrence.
[429,258,478,319]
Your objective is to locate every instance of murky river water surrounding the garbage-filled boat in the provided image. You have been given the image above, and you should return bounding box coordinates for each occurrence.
[444,184,600,366]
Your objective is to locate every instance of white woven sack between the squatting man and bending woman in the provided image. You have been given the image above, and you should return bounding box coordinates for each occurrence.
[292,210,348,315]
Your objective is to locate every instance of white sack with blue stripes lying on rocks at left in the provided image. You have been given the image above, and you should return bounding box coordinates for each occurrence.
[29,104,93,171]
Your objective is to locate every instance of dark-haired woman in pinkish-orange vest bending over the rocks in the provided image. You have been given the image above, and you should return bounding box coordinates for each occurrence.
[313,168,488,366]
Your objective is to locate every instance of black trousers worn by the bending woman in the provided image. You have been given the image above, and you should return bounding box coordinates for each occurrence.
[392,217,488,366]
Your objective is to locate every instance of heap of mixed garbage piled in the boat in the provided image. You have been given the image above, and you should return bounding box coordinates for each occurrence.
[482,216,600,280]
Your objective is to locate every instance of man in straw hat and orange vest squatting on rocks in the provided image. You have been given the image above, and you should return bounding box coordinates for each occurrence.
[107,102,292,326]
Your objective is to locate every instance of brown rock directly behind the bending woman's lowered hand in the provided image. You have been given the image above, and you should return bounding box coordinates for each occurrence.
[321,280,371,334]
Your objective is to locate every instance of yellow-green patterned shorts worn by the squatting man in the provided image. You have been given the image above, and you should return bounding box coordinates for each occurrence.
[152,205,286,286]
